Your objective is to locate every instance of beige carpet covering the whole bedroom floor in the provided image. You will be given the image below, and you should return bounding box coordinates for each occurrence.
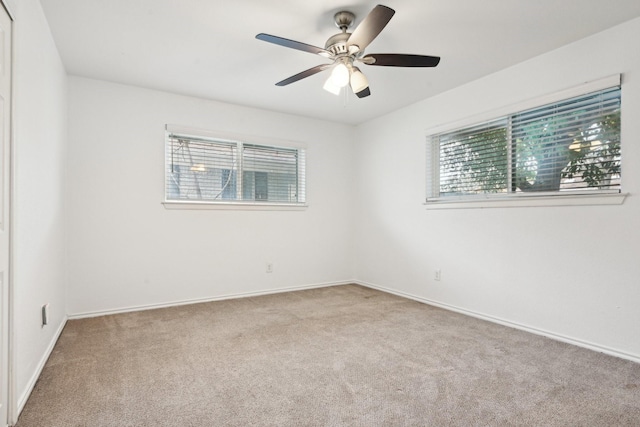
[17,285,640,427]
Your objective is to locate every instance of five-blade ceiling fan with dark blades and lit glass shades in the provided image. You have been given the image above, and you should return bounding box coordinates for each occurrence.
[256,4,440,98]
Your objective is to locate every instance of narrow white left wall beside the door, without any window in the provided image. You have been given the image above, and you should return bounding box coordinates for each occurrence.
[13,0,67,414]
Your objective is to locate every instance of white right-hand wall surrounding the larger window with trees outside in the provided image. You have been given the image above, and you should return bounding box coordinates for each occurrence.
[355,19,640,361]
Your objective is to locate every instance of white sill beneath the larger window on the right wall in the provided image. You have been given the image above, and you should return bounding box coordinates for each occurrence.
[424,193,628,210]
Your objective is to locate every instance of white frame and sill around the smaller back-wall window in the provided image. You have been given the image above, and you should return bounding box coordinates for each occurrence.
[162,124,308,210]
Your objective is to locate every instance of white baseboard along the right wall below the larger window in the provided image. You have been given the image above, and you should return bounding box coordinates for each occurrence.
[353,280,640,363]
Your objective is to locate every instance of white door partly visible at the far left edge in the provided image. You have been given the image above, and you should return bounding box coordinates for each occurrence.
[0,5,12,426]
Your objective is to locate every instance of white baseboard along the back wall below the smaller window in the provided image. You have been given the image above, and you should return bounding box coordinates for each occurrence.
[68,280,355,320]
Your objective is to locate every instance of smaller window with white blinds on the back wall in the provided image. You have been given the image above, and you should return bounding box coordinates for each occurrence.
[165,131,305,205]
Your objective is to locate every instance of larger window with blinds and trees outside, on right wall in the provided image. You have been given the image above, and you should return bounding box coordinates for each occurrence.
[427,85,621,207]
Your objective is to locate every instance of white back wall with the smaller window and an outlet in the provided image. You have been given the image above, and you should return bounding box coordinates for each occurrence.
[68,77,353,315]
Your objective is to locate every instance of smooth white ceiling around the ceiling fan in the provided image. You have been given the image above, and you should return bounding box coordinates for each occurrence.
[40,0,640,124]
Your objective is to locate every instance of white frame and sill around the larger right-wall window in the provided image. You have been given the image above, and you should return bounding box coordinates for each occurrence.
[425,74,627,209]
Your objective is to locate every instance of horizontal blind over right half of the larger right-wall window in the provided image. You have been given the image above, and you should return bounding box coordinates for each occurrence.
[511,88,620,191]
